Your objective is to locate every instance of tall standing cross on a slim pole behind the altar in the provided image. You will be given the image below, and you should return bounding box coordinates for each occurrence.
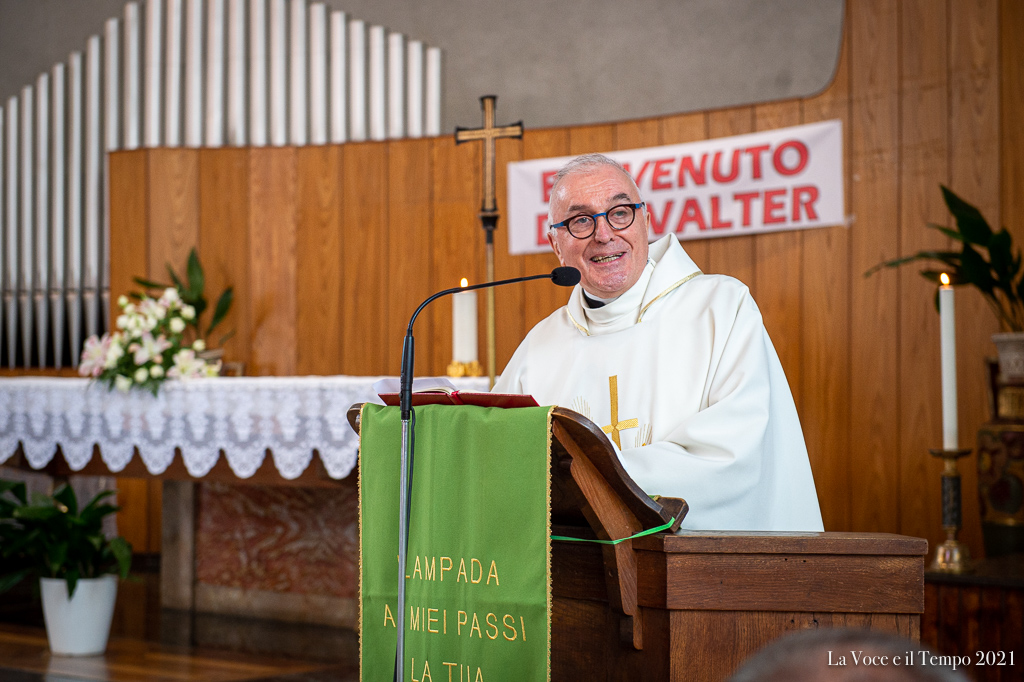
[455,95,522,387]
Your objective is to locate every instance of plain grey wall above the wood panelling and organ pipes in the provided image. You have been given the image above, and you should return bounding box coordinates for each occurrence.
[0,0,844,130]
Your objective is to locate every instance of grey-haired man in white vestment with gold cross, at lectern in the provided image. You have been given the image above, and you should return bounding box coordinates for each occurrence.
[494,155,822,530]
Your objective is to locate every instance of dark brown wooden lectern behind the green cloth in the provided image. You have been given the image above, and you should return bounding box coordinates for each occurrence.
[348,406,928,682]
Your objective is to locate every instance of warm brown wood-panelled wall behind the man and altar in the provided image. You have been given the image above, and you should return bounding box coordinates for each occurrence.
[97,0,1024,554]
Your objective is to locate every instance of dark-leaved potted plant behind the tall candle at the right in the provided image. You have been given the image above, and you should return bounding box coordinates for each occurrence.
[864,185,1024,381]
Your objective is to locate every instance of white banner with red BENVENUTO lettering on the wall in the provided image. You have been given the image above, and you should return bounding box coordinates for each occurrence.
[508,120,845,255]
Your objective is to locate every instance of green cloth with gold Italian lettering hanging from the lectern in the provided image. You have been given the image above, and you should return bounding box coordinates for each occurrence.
[359,404,551,682]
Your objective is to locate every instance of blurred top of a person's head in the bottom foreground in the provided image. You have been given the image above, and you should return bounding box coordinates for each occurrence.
[729,628,971,682]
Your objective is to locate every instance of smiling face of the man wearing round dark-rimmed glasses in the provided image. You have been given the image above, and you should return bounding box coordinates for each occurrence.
[548,166,649,299]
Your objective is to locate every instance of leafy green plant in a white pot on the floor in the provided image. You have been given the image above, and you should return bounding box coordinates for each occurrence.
[0,479,131,655]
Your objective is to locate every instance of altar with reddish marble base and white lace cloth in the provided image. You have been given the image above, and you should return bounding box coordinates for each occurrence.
[0,376,486,627]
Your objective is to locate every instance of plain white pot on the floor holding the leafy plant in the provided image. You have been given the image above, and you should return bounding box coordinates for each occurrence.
[39,576,118,656]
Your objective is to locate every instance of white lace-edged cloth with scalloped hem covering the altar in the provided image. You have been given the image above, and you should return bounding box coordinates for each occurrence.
[0,377,487,480]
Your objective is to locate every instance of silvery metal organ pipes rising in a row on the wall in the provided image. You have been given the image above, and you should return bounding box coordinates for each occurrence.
[0,0,441,368]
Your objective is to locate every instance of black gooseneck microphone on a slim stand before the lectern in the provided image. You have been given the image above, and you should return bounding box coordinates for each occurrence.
[394,267,580,682]
